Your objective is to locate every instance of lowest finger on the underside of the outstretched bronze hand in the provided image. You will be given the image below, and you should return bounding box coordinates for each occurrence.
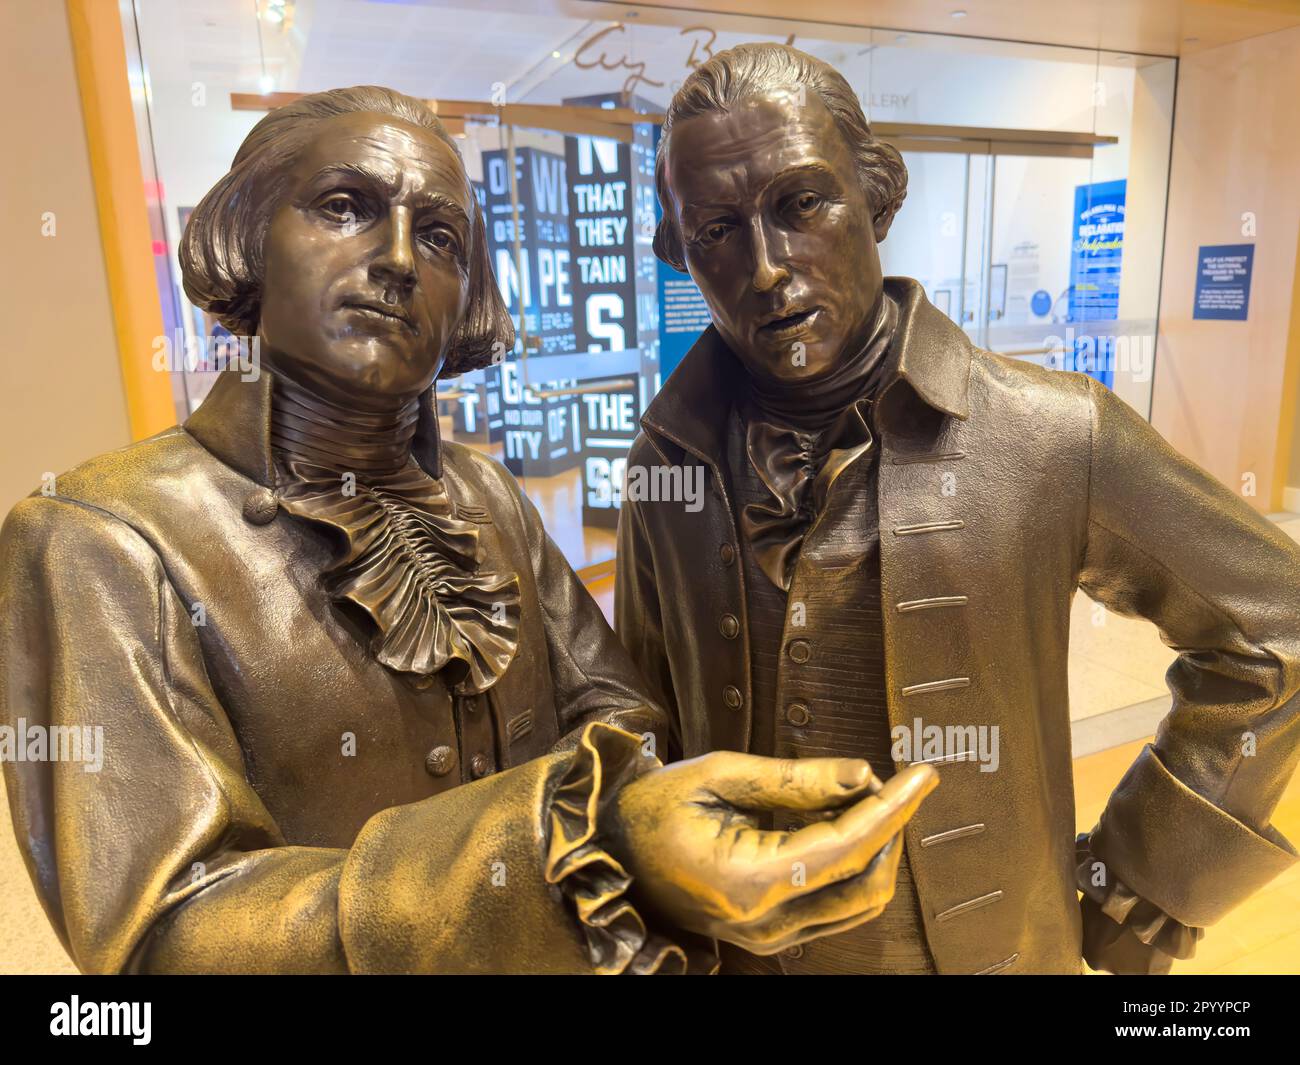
[740,834,904,954]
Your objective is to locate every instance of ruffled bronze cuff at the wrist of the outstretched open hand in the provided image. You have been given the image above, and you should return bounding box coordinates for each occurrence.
[545,722,718,974]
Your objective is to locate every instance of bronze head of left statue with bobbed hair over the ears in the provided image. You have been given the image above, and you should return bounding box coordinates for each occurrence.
[181,86,514,408]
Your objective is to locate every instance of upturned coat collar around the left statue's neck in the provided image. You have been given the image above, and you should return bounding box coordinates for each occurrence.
[185,369,442,488]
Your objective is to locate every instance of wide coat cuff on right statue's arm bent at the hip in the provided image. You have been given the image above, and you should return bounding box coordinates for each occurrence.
[1089,744,1297,927]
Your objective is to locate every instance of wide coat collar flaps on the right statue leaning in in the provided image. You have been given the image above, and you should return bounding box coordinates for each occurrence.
[641,277,972,462]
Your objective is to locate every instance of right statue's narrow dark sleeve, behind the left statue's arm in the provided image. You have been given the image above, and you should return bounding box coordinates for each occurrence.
[614,440,683,761]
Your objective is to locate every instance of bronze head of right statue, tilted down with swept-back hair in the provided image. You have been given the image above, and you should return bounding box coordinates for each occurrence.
[654,44,907,384]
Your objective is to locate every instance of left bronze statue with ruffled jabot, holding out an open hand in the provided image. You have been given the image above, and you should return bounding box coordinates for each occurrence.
[0,87,937,973]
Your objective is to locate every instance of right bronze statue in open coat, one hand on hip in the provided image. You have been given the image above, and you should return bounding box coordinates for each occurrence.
[615,44,1300,973]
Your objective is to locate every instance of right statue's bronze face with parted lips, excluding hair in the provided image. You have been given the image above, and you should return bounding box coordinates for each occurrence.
[664,91,881,385]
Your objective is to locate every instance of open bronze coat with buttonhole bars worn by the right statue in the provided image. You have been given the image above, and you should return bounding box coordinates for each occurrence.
[616,278,1300,973]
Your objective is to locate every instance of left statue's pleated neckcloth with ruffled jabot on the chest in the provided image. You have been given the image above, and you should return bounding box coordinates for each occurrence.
[272,376,519,694]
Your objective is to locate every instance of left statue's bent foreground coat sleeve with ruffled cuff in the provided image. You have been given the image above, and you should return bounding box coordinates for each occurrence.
[0,497,685,973]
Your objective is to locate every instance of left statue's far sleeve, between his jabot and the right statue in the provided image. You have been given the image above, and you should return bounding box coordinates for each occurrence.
[511,479,668,749]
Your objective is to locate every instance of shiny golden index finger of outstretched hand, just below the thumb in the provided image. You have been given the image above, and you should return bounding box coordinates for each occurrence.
[728,766,939,914]
